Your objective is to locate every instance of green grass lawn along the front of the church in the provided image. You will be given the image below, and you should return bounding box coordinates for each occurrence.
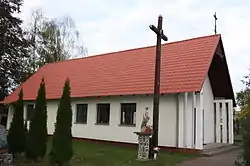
[12,140,197,166]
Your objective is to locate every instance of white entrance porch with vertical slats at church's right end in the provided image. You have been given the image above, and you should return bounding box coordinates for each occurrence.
[176,93,234,150]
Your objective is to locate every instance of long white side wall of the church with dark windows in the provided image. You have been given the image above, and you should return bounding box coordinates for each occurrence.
[8,95,176,147]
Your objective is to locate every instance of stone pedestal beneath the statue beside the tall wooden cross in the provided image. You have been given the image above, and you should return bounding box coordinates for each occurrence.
[134,132,152,160]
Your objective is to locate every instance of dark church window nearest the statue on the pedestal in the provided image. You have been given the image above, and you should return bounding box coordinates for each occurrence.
[121,103,136,125]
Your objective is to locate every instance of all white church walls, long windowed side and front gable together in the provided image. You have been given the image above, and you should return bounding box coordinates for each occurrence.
[4,77,214,148]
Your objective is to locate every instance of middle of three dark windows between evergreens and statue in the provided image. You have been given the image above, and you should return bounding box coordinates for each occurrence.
[97,104,110,124]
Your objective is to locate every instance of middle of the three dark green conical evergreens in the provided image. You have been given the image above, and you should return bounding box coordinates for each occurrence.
[26,79,47,160]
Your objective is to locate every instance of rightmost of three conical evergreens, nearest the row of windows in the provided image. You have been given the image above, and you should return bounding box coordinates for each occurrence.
[50,79,73,165]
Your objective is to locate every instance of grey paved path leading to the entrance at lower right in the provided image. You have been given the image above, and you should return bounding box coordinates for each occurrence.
[178,150,240,166]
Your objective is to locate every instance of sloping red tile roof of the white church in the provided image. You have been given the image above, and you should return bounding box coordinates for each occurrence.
[3,35,221,103]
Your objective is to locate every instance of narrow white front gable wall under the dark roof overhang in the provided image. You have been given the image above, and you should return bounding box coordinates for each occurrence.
[202,76,215,143]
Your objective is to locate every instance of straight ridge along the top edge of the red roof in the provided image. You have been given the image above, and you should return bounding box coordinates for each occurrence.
[47,34,221,65]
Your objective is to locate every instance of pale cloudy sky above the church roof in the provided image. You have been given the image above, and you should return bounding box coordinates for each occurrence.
[20,0,250,92]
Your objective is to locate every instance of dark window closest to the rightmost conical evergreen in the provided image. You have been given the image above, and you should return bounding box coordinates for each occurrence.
[76,104,88,123]
